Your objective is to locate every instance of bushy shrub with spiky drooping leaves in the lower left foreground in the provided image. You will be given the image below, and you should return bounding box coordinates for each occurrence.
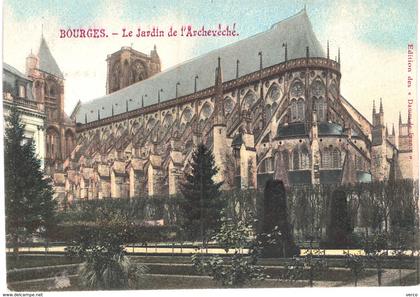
[67,207,147,290]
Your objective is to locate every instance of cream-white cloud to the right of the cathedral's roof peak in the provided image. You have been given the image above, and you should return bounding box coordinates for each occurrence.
[321,2,407,129]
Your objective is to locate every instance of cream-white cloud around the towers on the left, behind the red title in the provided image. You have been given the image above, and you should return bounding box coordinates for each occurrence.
[3,1,198,114]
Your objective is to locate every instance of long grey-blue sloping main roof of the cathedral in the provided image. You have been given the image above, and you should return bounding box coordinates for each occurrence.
[76,10,325,123]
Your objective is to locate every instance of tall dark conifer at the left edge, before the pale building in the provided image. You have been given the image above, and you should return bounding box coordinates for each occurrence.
[4,106,57,257]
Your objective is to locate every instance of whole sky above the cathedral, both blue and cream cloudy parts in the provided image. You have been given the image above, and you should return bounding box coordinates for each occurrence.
[3,0,417,128]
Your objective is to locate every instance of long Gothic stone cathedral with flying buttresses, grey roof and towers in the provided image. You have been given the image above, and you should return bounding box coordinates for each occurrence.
[46,10,412,202]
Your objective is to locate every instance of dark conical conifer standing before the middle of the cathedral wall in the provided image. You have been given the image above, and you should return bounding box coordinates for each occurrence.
[181,144,224,244]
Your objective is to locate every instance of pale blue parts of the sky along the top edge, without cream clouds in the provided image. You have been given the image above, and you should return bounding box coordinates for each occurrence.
[6,0,417,51]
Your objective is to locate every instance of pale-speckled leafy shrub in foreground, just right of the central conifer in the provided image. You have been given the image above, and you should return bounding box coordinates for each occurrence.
[192,218,266,288]
